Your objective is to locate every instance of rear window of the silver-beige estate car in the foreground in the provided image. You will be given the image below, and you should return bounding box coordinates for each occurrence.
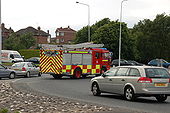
[145,68,170,78]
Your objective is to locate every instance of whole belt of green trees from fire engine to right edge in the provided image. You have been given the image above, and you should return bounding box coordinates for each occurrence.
[75,14,170,63]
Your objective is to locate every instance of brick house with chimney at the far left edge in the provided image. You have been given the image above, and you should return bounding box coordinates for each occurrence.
[1,23,14,49]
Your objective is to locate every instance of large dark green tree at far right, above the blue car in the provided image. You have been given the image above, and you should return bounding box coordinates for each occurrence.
[132,14,170,62]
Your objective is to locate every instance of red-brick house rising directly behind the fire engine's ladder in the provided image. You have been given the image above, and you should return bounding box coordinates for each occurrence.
[55,26,76,44]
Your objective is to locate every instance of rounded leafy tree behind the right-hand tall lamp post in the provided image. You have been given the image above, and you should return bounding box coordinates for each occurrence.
[92,21,134,59]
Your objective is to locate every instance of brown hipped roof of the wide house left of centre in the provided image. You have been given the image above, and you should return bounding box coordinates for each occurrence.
[16,26,50,36]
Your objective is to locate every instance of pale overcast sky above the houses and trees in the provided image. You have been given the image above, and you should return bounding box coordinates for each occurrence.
[1,0,170,37]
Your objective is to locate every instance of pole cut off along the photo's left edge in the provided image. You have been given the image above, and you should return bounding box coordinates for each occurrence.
[0,0,2,64]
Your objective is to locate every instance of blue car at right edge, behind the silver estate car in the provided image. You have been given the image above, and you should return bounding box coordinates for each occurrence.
[148,59,170,69]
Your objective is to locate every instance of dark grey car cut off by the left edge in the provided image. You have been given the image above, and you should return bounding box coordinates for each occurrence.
[0,64,16,79]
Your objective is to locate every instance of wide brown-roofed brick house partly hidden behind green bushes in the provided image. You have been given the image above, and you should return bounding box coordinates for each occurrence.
[16,26,51,44]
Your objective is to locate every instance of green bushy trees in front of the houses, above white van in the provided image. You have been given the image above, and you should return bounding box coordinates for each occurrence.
[4,33,35,50]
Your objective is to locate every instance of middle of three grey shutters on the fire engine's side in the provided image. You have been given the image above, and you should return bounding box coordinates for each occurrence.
[72,54,82,64]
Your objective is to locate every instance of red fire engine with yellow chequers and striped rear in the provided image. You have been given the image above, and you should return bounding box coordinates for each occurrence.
[40,42,111,79]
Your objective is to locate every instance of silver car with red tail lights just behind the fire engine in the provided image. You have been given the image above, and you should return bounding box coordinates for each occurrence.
[11,62,41,78]
